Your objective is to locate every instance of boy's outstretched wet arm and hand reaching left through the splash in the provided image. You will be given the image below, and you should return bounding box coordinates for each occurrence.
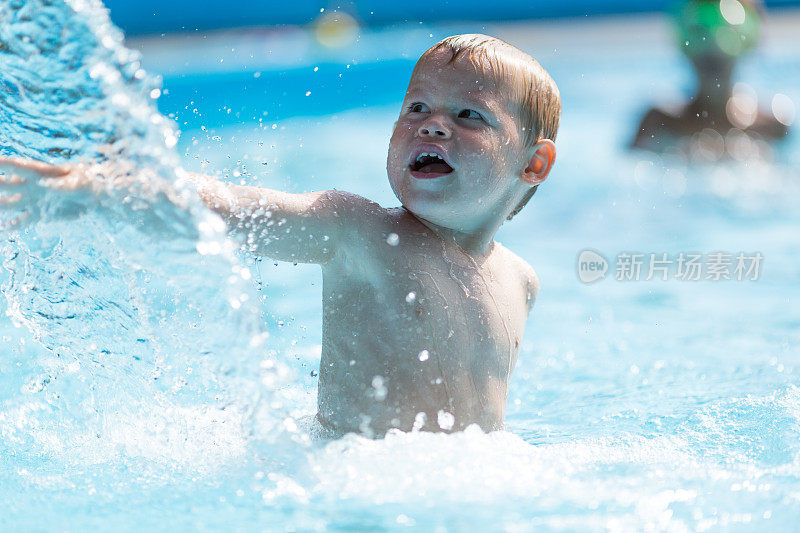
[0,157,354,263]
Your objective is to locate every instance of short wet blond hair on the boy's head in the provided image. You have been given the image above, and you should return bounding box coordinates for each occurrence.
[417,33,561,220]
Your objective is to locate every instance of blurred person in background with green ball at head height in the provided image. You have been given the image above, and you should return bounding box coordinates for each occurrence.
[632,0,790,160]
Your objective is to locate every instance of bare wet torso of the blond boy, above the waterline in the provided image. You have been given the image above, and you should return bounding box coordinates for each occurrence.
[318,203,534,434]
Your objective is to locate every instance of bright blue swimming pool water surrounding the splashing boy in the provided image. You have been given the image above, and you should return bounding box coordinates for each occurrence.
[0,1,800,531]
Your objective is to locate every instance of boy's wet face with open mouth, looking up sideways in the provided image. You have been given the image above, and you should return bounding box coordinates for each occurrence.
[387,52,527,232]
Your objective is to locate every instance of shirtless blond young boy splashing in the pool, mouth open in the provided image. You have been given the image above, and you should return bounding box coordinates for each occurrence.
[0,35,561,435]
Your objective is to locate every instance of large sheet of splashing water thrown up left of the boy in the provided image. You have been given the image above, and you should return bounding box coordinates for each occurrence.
[0,0,296,485]
